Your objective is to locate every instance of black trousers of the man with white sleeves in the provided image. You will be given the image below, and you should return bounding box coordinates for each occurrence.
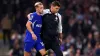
[36,36,63,56]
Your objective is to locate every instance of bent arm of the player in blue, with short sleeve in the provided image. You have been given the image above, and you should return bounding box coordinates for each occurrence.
[26,16,37,40]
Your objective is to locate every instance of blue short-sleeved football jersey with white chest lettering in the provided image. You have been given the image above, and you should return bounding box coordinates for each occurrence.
[24,12,42,42]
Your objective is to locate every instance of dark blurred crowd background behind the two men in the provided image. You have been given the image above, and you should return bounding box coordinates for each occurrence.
[0,0,100,56]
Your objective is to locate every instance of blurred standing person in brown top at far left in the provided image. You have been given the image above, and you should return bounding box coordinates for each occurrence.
[1,14,12,48]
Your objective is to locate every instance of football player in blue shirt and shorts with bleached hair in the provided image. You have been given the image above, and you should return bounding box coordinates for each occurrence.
[24,2,46,56]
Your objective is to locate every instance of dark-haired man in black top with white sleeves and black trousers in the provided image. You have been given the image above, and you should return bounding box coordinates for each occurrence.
[27,1,63,56]
